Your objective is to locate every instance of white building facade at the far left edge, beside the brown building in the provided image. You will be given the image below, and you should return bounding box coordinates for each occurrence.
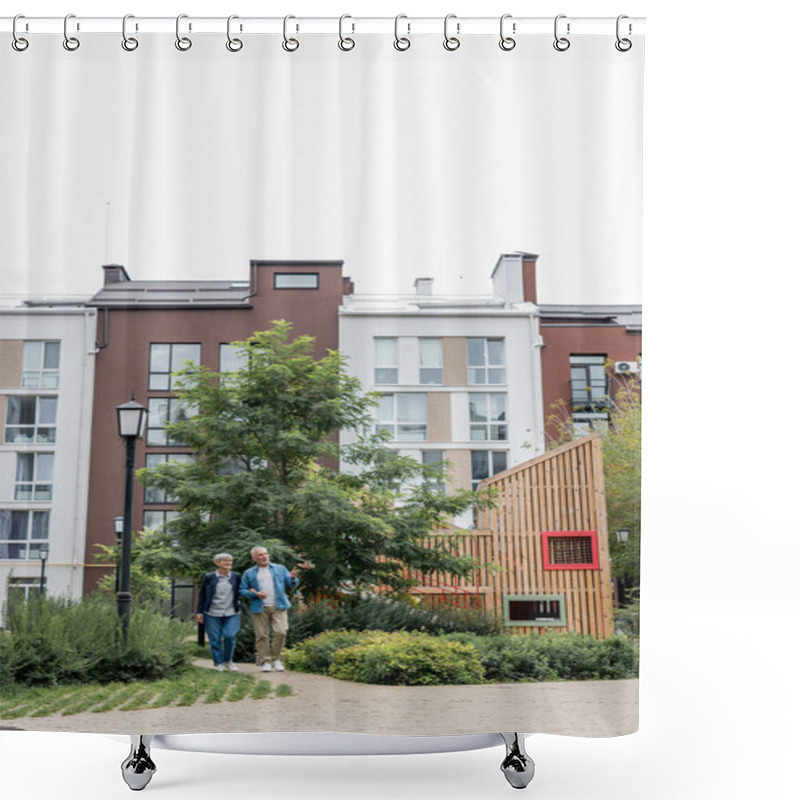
[0,305,97,624]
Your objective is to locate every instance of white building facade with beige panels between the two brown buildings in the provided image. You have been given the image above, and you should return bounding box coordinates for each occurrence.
[339,254,545,524]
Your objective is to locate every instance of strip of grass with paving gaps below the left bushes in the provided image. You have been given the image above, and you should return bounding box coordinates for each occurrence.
[0,667,292,720]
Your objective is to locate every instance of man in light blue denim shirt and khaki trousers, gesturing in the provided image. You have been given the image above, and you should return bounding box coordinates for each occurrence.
[239,547,300,672]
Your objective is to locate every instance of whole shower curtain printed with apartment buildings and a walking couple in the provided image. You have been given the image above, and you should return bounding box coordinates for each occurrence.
[0,15,644,736]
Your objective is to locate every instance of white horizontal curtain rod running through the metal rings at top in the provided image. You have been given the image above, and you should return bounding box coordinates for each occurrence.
[0,14,645,36]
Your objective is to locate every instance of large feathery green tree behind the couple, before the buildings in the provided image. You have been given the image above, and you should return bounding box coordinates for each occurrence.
[138,321,486,592]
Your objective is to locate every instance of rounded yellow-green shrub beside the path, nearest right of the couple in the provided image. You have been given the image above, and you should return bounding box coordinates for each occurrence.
[329,631,484,686]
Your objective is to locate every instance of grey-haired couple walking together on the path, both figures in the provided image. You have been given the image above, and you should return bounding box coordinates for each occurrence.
[196,547,300,672]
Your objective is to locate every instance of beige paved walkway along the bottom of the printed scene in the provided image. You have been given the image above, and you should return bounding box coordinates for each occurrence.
[0,660,639,737]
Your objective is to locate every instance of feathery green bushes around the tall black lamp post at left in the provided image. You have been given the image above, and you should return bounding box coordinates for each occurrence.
[0,596,192,686]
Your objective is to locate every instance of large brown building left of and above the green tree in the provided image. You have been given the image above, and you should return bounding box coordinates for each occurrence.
[84,261,353,592]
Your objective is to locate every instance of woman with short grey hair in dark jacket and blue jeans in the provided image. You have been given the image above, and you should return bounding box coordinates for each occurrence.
[196,553,242,672]
